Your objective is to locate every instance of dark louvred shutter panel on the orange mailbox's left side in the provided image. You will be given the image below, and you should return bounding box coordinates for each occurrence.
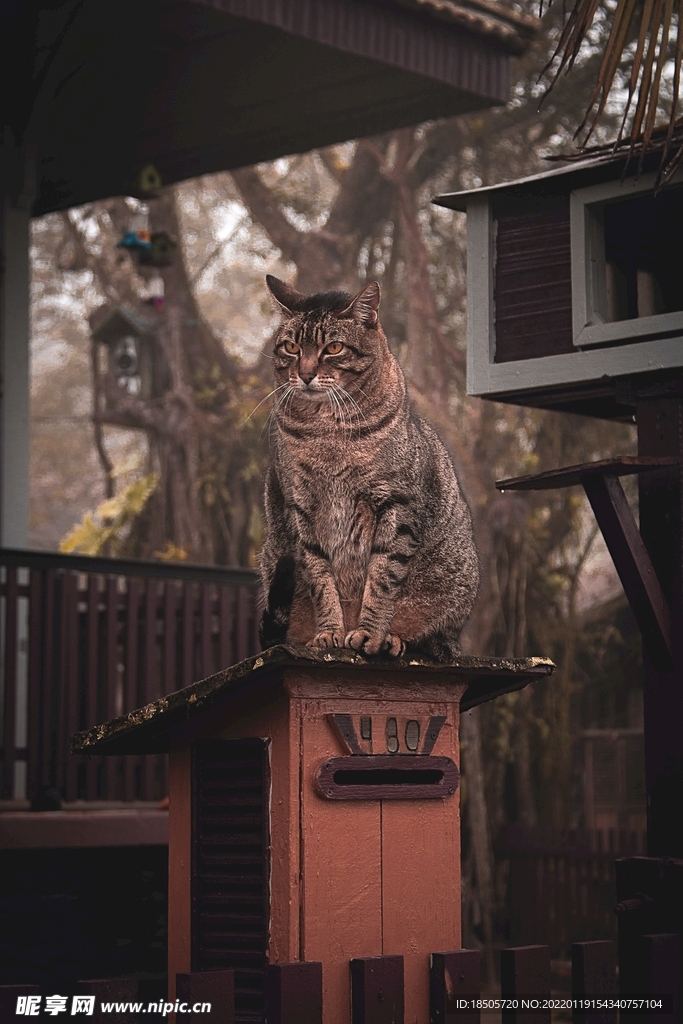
[191,739,270,1024]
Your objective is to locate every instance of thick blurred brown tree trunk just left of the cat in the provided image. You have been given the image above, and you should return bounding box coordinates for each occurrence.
[89,188,264,565]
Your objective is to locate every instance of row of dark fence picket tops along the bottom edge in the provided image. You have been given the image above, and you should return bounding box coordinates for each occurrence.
[0,934,680,1024]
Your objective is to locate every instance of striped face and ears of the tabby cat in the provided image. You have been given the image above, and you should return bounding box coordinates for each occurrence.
[266,278,381,410]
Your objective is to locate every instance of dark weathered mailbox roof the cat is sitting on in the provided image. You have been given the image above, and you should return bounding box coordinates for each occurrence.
[72,645,555,754]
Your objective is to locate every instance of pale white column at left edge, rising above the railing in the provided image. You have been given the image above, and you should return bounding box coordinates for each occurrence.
[0,190,31,548]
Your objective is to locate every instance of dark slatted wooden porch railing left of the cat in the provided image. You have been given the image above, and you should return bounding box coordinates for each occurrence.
[0,550,259,801]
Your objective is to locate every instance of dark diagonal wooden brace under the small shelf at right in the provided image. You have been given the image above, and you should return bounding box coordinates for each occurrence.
[581,473,673,666]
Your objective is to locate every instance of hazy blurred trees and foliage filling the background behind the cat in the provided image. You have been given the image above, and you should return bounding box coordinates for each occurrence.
[31,0,655,958]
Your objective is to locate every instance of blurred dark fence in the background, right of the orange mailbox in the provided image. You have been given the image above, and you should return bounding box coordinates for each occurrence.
[496,825,646,957]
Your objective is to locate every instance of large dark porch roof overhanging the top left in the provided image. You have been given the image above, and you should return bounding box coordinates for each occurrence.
[0,0,537,214]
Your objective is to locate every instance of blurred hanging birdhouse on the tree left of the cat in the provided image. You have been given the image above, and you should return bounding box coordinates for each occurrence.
[90,306,166,409]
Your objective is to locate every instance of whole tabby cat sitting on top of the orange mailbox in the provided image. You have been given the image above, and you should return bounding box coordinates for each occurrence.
[261,276,479,660]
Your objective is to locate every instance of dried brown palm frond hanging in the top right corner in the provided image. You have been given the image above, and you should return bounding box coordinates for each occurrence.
[542,0,683,181]
